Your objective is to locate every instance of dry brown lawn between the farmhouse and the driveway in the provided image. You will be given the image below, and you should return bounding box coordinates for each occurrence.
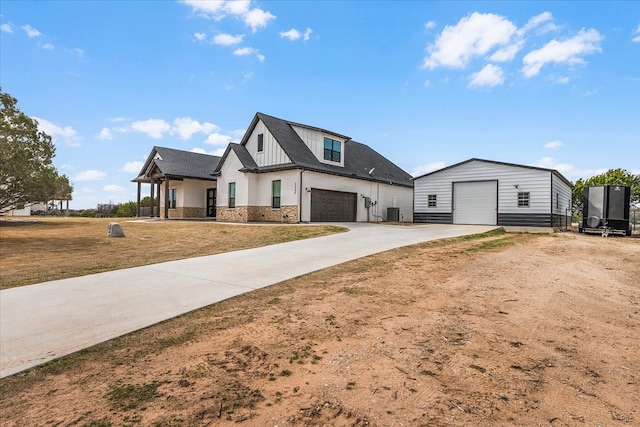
[0,218,344,289]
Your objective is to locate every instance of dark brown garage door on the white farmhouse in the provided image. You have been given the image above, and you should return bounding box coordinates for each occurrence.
[311,188,357,222]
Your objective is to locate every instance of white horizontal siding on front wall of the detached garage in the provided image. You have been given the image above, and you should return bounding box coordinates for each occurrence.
[414,160,552,227]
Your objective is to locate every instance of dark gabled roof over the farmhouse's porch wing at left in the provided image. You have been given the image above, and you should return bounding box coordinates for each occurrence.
[133,147,221,182]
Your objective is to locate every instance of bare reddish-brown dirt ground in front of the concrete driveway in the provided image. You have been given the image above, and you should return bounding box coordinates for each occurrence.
[0,233,640,427]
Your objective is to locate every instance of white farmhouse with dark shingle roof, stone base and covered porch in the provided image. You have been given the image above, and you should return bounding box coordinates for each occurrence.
[133,113,413,223]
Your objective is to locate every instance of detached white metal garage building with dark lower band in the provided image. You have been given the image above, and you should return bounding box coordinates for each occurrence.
[413,158,572,228]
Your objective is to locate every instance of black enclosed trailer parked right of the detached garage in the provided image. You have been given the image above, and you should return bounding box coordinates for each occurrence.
[578,185,631,237]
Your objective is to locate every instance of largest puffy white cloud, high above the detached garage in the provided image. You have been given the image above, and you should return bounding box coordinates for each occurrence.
[423,12,517,70]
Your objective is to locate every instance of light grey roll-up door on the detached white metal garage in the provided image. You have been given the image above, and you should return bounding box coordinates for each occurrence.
[453,181,498,225]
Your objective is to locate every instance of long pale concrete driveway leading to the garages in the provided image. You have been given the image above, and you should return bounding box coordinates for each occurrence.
[0,223,496,378]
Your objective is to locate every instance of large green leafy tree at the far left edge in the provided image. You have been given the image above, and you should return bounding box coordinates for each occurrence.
[0,88,63,212]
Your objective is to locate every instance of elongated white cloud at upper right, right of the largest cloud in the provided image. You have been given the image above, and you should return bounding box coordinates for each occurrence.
[522,28,603,78]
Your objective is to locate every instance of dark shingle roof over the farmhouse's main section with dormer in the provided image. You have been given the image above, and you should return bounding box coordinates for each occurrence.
[228,113,413,187]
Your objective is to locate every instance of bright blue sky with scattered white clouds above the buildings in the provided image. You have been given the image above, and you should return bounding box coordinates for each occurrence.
[0,0,640,209]
